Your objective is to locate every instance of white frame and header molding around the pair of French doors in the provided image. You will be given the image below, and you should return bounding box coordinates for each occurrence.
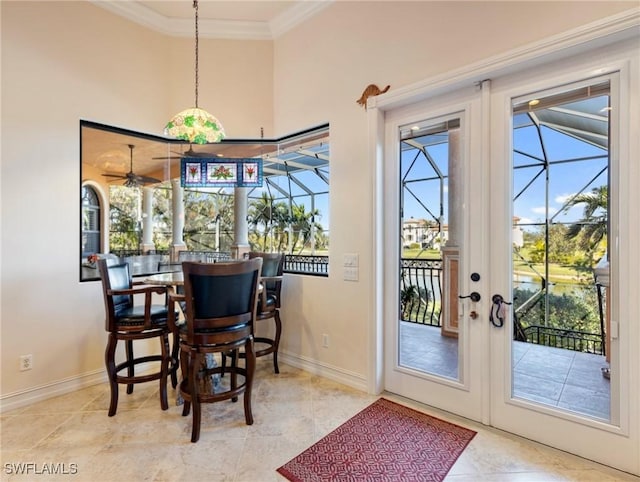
[368,9,640,475]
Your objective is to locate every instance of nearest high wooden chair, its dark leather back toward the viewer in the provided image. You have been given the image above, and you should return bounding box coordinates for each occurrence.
[169,259,262,442]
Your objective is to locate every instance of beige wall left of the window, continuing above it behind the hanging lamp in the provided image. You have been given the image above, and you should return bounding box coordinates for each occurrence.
[0,1,273,404]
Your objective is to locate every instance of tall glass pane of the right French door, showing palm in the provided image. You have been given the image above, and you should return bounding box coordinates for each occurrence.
[512,82,611,421]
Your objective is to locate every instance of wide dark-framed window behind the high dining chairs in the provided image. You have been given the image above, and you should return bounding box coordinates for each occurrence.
[80,121,330,280]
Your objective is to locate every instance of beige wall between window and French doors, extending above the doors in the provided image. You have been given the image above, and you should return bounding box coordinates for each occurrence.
[274,2,636,386]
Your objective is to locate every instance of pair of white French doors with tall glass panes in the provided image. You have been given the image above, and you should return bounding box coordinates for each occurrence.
[383,50,640,473]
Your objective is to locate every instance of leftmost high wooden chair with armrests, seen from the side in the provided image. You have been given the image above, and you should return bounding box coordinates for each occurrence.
[97,259,177,417]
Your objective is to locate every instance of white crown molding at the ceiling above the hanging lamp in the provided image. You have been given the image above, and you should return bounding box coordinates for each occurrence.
[89,0,334,40]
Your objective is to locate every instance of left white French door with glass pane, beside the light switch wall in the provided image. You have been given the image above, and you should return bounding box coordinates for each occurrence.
[384,84,487,420]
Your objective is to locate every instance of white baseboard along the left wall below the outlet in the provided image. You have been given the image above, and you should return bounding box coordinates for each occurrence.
[0,368,107,414]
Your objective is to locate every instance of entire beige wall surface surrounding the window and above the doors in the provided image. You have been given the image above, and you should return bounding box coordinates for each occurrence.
[0,1,637,405]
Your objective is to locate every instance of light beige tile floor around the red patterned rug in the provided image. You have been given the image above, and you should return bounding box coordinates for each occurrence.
[0,357,640,482]
